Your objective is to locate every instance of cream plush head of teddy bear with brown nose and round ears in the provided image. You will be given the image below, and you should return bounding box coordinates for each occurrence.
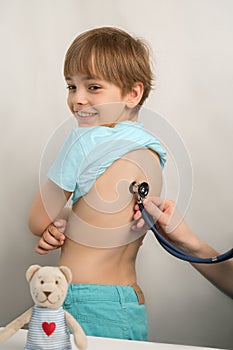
[26,265,72,309]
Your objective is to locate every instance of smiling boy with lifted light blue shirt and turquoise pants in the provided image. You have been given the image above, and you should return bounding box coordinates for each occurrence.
[29,27,165,340]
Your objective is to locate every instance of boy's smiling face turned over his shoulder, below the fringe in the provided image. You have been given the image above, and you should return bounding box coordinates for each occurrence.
[66,74,136,127]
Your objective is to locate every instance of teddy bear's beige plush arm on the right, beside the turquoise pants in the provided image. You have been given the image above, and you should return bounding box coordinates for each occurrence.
[64,311,87,350]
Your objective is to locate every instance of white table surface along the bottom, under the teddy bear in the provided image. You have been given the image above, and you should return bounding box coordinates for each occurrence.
[0,330,227,350]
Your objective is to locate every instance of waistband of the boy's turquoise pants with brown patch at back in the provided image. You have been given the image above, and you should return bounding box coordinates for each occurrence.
[66,283,145,304]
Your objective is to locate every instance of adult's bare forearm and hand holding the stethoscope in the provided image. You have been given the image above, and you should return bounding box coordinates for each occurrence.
[134,197,233,298]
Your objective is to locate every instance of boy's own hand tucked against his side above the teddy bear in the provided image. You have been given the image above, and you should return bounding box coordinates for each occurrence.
[35,219,66,255]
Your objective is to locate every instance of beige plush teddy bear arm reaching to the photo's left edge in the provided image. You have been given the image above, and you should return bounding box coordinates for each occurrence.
[0,308,32,343]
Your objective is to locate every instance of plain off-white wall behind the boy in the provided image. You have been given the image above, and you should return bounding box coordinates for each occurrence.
[0,0,233,349]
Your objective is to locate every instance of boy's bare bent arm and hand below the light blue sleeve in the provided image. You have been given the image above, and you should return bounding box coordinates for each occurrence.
[28,180,71,254]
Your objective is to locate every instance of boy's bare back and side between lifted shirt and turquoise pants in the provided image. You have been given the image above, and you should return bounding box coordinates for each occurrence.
[59,149,162,285]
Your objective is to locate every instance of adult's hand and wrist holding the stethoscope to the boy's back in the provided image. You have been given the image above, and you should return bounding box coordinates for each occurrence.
[132,197,200,252]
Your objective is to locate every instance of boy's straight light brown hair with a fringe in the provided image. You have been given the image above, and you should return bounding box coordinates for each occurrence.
[64,27,153,105]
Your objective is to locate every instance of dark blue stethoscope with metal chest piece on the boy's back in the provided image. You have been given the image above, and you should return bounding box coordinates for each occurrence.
[129,181,233,264]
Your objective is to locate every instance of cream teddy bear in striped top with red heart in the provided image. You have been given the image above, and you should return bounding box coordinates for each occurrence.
[0,265,87,350]
